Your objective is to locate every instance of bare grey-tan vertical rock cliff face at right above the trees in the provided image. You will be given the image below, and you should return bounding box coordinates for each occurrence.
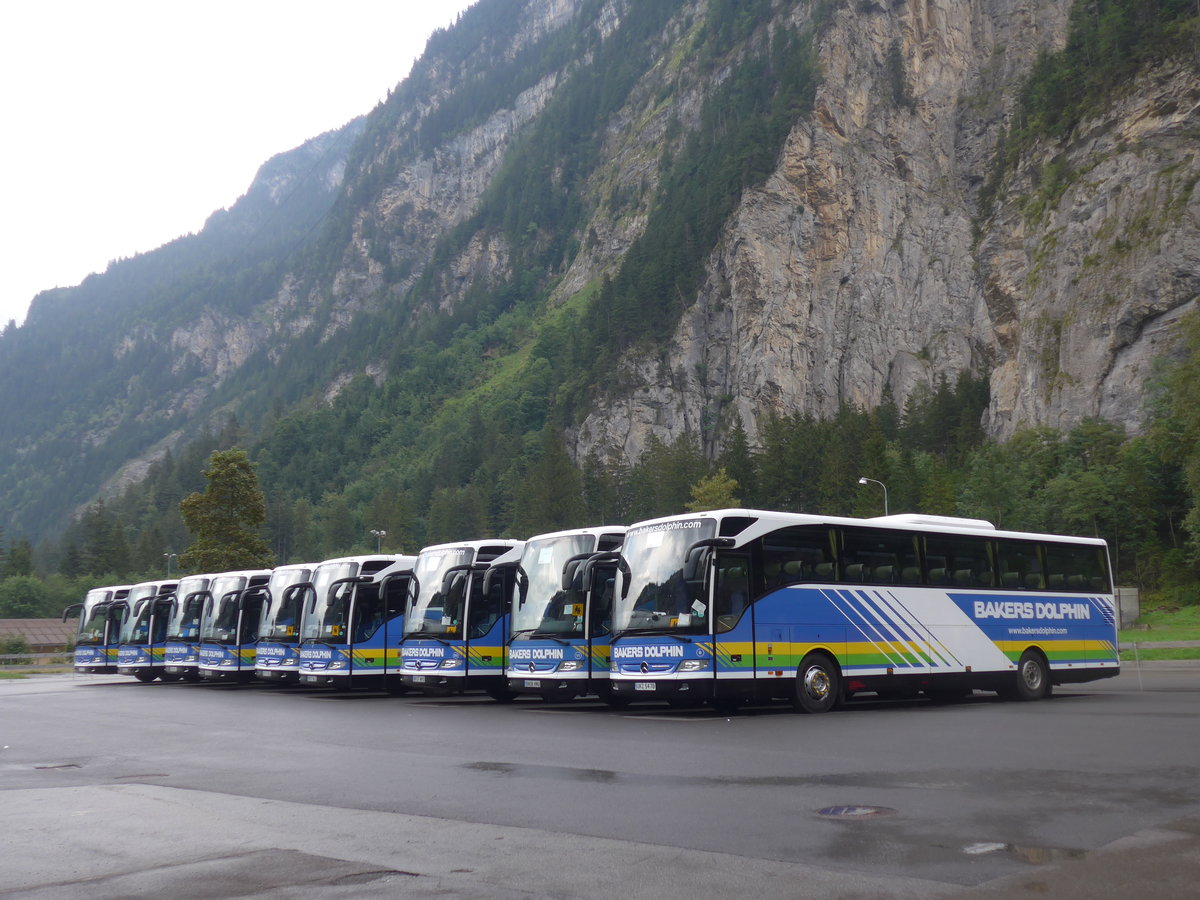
[576,0,1200,457]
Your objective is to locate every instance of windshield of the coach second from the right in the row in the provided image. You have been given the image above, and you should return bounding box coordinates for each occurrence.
[512,534,596,637]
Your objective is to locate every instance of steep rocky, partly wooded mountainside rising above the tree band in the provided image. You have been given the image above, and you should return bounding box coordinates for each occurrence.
[0,0,1200,549]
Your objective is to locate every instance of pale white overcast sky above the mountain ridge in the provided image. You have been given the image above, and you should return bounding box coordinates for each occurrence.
[0,0,473,328]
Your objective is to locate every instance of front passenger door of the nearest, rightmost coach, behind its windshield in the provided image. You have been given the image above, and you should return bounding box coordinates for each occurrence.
[704,550,755,697]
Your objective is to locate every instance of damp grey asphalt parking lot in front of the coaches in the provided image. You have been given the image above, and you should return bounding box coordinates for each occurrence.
[0,664,1200,898]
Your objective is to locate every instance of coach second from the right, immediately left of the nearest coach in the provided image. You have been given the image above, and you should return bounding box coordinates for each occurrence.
[506,526,625,701]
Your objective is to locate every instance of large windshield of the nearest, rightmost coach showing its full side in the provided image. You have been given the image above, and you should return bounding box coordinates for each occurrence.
[613,517,716,634]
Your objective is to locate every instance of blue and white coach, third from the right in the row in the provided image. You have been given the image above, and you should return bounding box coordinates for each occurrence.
[400,539,523,701]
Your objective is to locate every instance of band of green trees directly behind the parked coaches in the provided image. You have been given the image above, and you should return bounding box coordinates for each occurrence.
[9,304,1200,617]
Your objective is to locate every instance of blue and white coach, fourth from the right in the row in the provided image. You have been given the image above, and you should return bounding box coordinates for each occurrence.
[300,554,416,692]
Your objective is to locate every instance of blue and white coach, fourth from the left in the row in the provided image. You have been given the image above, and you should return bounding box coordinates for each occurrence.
[199,569,271,684]
